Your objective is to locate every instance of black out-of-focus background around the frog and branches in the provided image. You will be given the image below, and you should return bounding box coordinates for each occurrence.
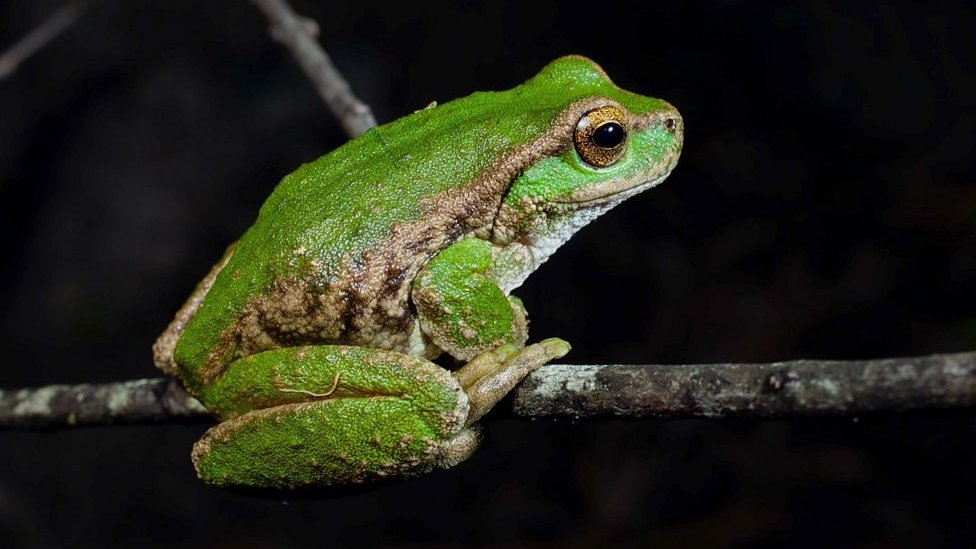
[0,0,976,547]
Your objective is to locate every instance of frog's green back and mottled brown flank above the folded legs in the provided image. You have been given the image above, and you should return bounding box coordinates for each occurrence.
[156,54,664,378]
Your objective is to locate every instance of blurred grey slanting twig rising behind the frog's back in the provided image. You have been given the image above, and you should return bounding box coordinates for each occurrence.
[251,0,376,137]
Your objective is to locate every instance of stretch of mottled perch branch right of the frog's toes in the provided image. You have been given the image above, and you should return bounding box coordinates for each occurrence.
[514,353,976,418]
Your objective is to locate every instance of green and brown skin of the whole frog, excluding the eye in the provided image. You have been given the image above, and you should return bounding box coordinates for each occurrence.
[154,57,683,490]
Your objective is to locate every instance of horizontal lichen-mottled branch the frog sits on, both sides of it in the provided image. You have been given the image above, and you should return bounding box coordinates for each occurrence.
[0,352,976,429]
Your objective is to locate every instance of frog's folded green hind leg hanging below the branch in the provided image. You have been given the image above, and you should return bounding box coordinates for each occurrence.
[193,345,479,490]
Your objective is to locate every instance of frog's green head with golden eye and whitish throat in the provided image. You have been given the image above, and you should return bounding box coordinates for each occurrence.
[492,57,684,282]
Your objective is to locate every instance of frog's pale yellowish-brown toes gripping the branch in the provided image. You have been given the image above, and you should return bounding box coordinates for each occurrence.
[454,337,570,426]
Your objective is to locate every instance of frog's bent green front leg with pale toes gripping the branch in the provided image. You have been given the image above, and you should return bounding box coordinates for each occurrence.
[411,238,569,425]
